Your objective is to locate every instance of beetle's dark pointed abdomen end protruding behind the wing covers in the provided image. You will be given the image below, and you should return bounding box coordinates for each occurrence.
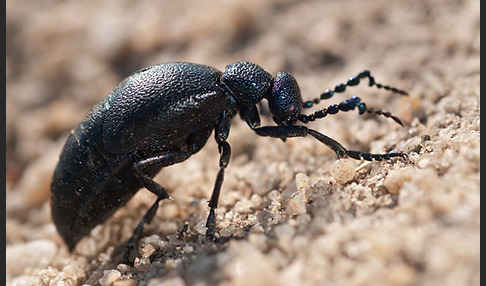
[51,122,146,250]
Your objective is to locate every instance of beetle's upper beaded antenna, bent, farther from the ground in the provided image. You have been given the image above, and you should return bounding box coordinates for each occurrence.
[304,70,408,108]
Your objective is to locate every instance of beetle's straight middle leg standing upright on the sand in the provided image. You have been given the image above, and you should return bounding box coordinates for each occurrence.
[206,112,231,241]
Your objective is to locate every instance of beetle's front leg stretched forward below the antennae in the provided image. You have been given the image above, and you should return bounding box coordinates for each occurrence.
[254,126,407,161]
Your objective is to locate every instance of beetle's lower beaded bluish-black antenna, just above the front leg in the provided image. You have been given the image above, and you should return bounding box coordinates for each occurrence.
[298,96,403,126]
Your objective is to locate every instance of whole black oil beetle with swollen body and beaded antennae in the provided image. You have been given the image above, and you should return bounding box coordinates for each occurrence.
[51,62,407,260]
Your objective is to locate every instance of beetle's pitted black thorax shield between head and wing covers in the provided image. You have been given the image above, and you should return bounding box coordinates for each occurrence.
[223,62,273,107]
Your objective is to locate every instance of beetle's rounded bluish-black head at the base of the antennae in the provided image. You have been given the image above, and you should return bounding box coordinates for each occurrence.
[266,72,302,125]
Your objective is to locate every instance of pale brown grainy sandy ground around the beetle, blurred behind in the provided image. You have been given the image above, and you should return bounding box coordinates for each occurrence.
[6,0,480,286]
